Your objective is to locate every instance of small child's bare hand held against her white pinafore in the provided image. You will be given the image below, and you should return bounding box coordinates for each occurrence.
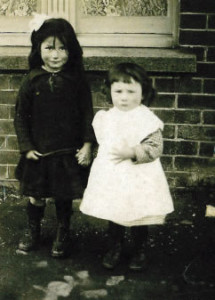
[110,141,135,163]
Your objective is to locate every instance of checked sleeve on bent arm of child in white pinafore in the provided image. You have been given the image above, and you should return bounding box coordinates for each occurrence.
[134,129,163,164]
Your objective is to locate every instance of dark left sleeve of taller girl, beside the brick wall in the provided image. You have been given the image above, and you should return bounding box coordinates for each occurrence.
[14,75,35,153]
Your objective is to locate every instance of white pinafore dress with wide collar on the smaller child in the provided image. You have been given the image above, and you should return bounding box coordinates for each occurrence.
[80,105,174,226]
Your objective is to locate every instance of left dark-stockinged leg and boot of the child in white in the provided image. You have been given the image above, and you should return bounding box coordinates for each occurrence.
[102,222,125,269]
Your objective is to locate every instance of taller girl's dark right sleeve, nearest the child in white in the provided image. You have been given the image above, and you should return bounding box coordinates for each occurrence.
[78,78,96,142]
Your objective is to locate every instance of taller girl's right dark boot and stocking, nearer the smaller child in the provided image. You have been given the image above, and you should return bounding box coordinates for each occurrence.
[51,200,72,258]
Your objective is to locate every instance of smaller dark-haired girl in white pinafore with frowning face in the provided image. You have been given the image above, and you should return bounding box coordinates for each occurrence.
[80,63,173,270]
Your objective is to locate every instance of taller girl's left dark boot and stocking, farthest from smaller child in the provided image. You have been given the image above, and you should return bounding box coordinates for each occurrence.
[18,201,45,252]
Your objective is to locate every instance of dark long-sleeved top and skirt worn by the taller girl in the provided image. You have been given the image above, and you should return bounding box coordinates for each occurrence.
[14,69,94,198]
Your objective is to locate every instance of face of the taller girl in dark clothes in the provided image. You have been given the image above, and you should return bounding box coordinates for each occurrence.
[40,36,68,72]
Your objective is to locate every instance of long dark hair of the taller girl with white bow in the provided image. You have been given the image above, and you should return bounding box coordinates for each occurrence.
[28,18,83,69]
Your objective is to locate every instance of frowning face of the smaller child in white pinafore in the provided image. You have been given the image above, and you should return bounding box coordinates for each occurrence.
[111,79,143,111]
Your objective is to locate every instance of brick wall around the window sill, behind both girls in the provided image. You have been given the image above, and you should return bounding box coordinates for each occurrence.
[0,0,215,195]
